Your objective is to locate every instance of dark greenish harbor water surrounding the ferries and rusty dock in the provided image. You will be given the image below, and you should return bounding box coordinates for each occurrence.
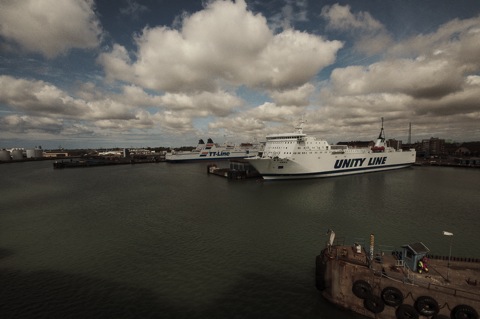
[0,161,480,319]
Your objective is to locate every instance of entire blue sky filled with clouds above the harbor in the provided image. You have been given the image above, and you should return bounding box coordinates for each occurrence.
[0,0,480,149]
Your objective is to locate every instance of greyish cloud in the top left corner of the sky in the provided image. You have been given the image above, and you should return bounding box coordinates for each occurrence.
[0,0,102,58]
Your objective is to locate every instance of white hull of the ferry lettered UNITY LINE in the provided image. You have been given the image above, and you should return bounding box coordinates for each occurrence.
[247,151,416,180]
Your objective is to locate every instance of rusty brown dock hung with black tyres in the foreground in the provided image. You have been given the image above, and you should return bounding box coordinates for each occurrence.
[316,235,480,319]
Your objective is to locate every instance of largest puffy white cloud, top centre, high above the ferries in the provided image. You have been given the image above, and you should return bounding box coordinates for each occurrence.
[98,0,342,92]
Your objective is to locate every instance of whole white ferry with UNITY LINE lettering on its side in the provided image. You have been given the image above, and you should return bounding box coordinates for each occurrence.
[247,118,416,179]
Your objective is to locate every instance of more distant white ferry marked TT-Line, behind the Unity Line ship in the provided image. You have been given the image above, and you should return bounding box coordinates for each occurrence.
[165,138,261,163]
